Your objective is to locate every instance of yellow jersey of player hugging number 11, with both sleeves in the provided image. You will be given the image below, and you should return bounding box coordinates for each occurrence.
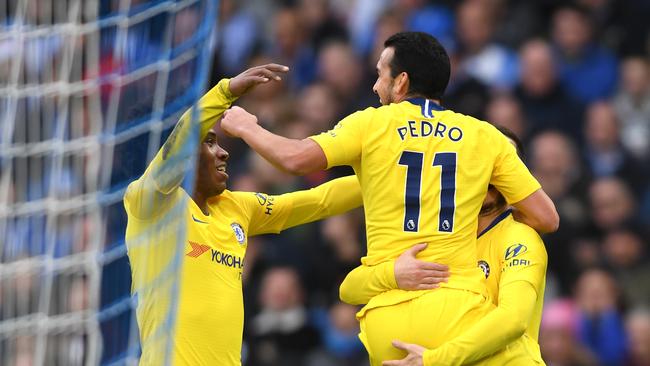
[334,210,547,366]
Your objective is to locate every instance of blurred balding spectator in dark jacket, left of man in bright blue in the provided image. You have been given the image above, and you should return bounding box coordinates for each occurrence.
[514,39,583,141]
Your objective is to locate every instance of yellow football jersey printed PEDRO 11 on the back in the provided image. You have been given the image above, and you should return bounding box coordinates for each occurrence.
[312,99,540,307]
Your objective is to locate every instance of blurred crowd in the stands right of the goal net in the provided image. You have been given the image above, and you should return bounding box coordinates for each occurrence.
[211,0,650,366]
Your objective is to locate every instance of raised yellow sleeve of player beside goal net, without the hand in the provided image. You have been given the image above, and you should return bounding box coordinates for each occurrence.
[124,79,237,219]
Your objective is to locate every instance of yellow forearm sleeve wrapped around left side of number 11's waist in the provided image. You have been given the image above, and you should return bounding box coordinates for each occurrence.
[339,260,398,305]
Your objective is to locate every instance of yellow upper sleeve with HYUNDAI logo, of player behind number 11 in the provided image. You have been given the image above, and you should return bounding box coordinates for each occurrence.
[499,224,548,293]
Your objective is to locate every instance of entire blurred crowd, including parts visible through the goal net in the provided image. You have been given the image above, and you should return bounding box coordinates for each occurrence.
[0,0,650,366]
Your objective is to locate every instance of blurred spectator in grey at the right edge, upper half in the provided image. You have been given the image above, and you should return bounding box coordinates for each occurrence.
[614,57,650,161]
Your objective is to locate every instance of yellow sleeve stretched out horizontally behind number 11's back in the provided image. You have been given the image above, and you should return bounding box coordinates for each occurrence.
[244,175,363,235]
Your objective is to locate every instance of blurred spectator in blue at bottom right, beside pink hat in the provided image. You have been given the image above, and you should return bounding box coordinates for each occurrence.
[575,269,627,366]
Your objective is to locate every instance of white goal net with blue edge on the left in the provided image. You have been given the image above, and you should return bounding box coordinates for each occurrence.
[0,0,218,366]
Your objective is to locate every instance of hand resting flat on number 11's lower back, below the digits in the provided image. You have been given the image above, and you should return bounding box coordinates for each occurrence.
[395,243,449,290]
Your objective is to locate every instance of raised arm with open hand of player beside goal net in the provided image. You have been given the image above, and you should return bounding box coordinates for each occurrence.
[125,64,288,218]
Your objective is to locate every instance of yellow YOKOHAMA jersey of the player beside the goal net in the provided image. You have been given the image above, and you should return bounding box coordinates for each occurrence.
[124,79,362,366]
